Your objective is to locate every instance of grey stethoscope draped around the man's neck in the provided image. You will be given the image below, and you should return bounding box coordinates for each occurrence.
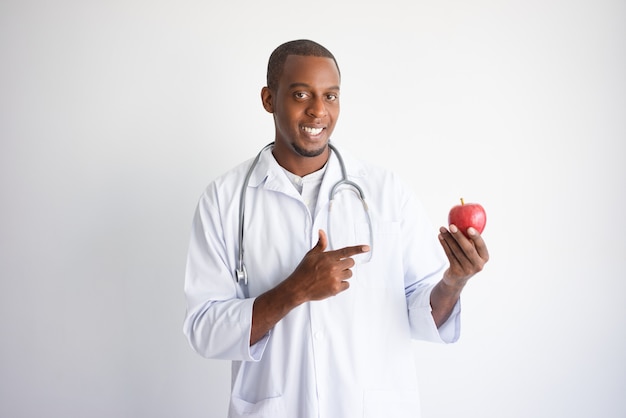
[235,142,374,297]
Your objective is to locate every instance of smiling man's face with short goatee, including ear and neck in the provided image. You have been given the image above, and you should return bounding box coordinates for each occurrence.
[261,55,340,175]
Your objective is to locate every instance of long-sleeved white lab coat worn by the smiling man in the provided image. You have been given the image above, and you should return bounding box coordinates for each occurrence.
[184,145,460,418]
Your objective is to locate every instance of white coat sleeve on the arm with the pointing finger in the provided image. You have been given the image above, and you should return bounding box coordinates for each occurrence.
[183,188,269,361]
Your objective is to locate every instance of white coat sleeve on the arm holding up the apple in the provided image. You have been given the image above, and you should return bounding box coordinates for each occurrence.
[402,183,461,343]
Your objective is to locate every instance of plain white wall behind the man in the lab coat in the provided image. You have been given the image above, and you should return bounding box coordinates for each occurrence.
[0,0,626,418]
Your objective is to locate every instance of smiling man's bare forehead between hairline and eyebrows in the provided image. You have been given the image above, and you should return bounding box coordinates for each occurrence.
[278,55,340,88]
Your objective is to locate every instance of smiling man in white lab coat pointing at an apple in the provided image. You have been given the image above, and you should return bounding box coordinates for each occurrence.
[184,40,489,418]
